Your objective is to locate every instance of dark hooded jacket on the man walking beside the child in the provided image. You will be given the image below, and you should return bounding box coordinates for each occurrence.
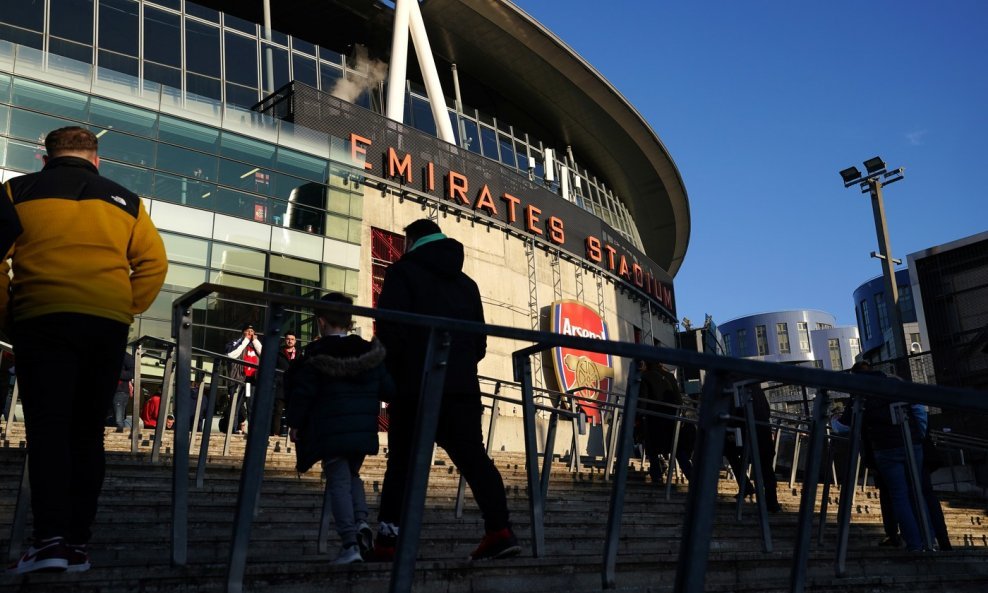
[377,238,487,399]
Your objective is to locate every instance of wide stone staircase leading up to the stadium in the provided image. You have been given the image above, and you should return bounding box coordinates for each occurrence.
[0,426,988,593]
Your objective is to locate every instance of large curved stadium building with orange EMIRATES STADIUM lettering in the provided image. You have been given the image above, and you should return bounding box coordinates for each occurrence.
[0,0,690,442]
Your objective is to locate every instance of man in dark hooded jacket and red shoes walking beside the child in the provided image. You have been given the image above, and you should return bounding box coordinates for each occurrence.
[375,219,521,560]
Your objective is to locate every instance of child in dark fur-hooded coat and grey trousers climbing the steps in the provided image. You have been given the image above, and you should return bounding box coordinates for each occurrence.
[285,293,394,564]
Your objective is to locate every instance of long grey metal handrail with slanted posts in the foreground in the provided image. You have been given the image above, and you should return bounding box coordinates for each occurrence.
[162,284,988,593]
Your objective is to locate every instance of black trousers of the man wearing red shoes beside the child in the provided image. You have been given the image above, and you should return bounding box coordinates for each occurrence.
[378,393,508,532]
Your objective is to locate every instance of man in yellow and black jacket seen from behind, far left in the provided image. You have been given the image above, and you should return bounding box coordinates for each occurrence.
[0,127,168,573]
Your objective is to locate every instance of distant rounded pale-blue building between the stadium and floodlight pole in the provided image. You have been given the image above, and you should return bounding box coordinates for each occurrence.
[720,309,861,371]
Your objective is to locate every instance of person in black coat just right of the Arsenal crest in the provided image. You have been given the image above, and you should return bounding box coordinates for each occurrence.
[638,360,696,485]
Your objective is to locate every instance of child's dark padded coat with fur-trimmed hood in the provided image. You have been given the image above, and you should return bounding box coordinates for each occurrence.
[285,335,394,472]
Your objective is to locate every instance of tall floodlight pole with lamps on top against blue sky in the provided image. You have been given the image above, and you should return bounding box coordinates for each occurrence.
[840,156,909,359]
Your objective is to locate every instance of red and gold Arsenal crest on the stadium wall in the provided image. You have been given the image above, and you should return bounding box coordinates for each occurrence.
[550,300,614,424]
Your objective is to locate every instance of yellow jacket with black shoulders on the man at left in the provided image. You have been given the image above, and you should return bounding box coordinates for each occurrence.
[0,156,168,325]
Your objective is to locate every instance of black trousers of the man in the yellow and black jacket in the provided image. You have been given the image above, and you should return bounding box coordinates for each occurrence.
[13,313,129,544]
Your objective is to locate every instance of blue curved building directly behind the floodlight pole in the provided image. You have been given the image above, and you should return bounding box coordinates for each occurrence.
[854,268,926,361]
